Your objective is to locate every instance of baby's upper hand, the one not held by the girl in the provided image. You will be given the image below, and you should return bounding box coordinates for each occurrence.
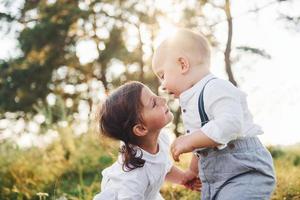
[171,135,193,162]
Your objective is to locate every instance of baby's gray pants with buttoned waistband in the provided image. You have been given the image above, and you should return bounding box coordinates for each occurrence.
[198,137,276,200]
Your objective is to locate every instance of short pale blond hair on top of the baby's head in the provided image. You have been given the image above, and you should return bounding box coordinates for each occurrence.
[152,29,210,67]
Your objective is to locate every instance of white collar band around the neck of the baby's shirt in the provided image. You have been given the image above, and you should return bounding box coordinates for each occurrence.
[179,73,214,105]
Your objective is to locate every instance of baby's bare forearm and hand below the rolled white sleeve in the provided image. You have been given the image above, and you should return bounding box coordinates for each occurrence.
[171,130,220,161]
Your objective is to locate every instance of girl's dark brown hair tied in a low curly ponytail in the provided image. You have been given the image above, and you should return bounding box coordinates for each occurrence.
[99,81,145,171]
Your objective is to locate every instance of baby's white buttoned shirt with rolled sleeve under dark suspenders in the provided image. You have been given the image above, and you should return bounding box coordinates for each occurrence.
[179,74,263,148]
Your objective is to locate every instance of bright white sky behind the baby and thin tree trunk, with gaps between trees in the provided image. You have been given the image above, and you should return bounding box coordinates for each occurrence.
[0,0,300,145]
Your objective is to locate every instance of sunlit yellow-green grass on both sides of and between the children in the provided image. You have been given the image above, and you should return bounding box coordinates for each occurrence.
[0,128,300,200]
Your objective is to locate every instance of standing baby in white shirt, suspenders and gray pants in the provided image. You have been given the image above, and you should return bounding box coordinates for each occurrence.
[152,29,275,200]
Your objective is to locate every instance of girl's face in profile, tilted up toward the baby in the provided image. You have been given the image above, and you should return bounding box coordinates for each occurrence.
[141,86,173,131]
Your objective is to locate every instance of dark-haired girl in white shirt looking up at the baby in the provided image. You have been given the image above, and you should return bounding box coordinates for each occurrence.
[94,82,201,200]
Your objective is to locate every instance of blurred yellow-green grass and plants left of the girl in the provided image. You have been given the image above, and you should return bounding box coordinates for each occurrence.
[0,127,117,200]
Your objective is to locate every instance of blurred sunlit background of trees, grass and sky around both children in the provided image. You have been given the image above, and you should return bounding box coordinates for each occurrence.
[0,0,300,200]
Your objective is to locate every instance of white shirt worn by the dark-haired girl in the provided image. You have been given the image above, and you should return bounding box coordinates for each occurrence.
[94,132,173,200]
